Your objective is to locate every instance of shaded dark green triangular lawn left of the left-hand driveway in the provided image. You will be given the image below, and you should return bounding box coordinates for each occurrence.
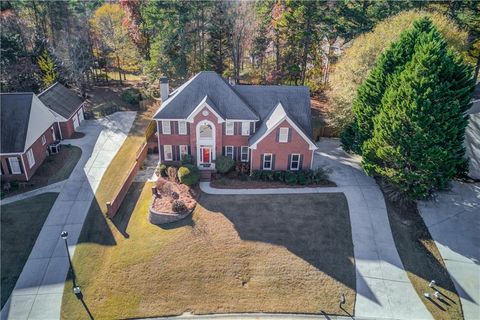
[1,193,58,308]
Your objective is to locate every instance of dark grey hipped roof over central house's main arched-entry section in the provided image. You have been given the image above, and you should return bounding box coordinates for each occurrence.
[153,71,259,121]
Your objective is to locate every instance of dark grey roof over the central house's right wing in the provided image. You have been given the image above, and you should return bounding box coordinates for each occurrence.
[233,85,312,139]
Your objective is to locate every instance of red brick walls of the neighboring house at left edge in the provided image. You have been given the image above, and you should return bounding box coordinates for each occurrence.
[1,125,54,181]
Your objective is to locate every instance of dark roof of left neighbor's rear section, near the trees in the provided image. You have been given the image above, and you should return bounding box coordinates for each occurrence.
[38,82,83,119]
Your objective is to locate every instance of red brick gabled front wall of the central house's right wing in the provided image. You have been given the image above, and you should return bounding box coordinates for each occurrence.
[251,120,312,170]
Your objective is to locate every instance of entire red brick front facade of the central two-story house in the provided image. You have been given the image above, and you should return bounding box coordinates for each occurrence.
[158,107,312,170]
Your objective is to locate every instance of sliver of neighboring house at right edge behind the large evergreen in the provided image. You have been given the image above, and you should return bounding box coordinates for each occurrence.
[465,84,480,180]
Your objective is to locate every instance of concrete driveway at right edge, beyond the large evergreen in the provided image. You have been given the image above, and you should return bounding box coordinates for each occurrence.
[418,182,480,320]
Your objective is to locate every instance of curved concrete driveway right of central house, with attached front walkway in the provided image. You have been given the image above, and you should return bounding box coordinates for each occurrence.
[200,139,432,319]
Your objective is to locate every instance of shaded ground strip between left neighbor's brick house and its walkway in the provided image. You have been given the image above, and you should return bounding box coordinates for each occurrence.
[2,145,82,198]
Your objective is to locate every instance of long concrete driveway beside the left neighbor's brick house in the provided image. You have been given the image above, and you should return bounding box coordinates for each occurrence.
[1,112,136,319]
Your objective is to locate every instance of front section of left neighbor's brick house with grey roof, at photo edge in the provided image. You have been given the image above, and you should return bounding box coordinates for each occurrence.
[0,92,57,181]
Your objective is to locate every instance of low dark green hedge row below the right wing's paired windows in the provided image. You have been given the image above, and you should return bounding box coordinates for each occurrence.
[252,169,327,185]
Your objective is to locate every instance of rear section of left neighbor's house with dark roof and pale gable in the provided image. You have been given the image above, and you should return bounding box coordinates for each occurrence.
[38,82,84,139]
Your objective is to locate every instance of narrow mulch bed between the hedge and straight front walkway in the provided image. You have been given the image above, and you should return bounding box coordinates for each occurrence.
[210,176,337,189]
